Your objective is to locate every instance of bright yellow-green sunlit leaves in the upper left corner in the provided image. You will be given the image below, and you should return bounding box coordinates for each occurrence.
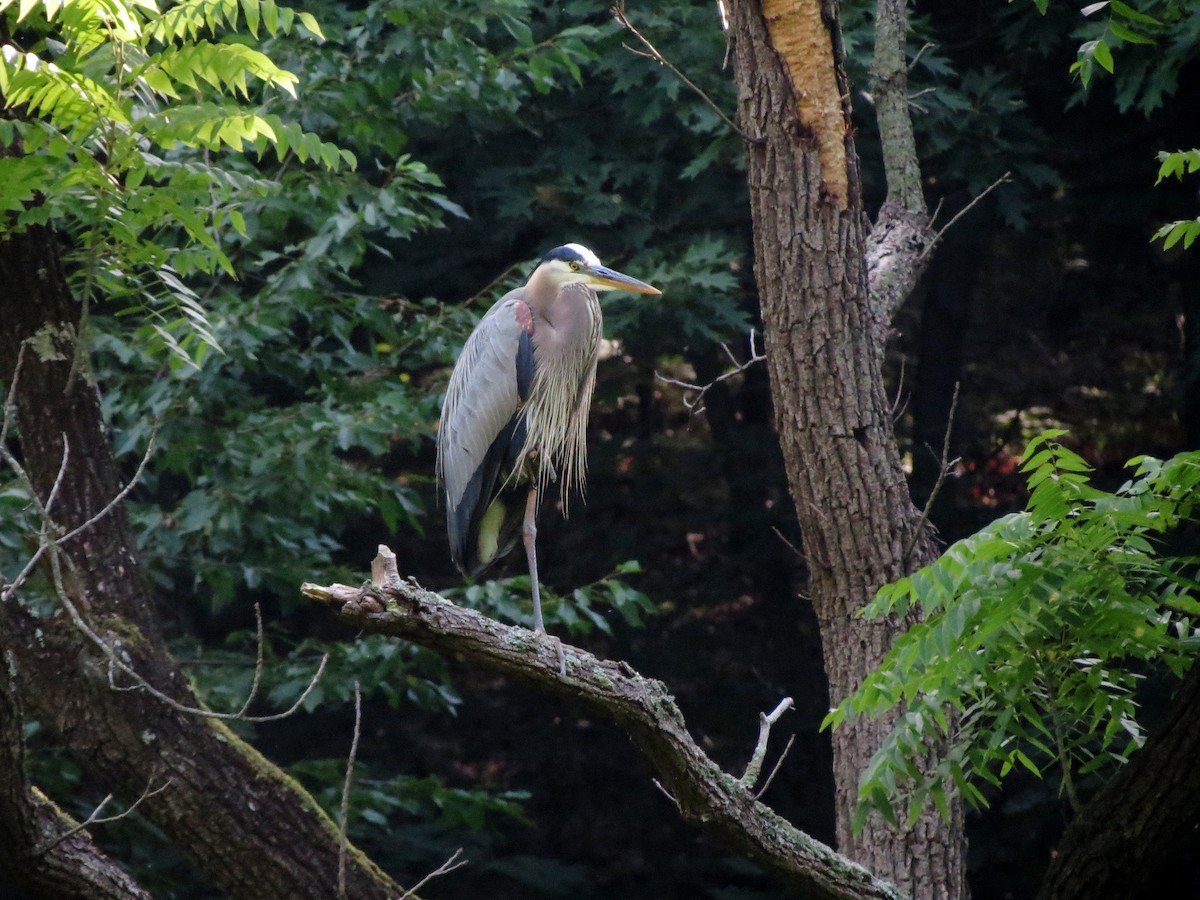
[0,0,355,361]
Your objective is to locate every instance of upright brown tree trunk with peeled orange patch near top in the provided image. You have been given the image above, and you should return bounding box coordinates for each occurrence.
[731,0,966,898]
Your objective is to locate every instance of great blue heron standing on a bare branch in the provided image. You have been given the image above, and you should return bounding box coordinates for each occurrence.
[438,244,661,631]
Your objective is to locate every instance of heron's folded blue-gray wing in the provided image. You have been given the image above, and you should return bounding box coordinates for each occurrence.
[438,292,533,572]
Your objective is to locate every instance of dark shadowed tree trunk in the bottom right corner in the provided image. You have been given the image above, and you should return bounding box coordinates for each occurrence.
[1038,666,1200,900]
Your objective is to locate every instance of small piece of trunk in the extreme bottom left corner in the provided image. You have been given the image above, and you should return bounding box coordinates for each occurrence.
[0,661,150,900]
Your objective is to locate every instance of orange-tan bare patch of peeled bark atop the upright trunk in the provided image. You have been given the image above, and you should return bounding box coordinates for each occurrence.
[762,0,850,209]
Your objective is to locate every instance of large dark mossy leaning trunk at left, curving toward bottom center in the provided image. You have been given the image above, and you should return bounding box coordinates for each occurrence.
[0,229,402,900]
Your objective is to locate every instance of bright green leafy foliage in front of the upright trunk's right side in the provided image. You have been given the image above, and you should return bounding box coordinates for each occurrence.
[826,430,1200,826]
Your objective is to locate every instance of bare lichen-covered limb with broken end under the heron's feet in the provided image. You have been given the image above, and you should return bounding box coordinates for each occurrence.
[300,547,902,899]
